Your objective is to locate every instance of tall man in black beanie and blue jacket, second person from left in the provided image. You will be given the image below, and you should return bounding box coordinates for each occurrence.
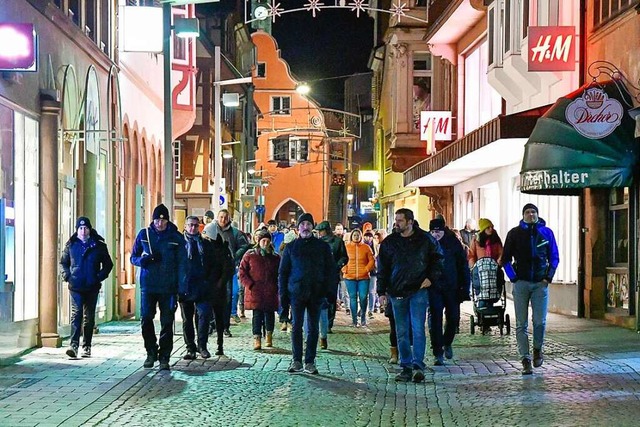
[131,204,187,370]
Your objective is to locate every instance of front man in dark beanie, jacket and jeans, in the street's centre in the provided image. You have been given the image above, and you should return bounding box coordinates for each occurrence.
[278,213,338,374]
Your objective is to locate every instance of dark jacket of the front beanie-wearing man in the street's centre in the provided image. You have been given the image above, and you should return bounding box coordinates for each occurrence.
[278,237,340,307]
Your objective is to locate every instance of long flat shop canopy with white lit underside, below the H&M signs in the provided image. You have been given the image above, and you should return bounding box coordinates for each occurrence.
[404,107,548,187]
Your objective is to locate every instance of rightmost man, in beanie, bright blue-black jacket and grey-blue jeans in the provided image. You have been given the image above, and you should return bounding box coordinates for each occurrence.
[501,203,560,375]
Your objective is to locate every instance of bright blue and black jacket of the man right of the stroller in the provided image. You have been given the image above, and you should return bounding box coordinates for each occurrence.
[500,218,560,283]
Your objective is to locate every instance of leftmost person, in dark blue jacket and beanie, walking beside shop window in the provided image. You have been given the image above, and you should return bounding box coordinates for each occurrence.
[60,216,113,358]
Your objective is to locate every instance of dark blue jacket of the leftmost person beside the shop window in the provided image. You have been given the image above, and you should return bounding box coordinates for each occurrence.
[60,229,113,292]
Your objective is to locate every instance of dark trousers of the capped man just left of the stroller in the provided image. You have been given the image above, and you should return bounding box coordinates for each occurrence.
[429,286,460,357]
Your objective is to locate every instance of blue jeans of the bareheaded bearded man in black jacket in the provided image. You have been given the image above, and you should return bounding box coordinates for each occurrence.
[390,288,429,369]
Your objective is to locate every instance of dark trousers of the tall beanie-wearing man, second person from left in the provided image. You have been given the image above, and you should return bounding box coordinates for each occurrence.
[140,291,178,362]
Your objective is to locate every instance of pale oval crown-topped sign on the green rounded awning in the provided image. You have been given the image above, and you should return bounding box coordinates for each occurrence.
[565,87,623,139]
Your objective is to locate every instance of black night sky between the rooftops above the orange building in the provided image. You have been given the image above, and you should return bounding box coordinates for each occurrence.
[272,0,373,109]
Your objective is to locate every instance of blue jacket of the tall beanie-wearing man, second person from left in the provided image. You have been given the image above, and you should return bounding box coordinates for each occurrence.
[131,222,187,294]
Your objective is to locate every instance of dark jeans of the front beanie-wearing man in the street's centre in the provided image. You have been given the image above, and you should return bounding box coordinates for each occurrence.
[291,300,321,363]
